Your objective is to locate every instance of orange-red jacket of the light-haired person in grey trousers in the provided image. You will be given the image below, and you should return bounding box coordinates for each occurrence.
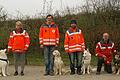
[8,30,30,52]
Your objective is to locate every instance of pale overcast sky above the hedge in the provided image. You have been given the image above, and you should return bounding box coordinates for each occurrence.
[0,0,85,16]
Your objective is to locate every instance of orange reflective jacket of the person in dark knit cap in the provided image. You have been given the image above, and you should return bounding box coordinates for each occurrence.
[64,28,85,53]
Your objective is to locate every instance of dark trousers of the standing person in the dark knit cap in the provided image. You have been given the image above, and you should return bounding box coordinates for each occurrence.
[68,52,83,73]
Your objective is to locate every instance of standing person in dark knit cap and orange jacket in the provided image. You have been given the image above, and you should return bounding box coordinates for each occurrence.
[64,20,85,75]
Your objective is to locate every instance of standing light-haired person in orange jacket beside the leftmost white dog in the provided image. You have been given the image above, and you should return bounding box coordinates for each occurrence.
[8,21,30,76]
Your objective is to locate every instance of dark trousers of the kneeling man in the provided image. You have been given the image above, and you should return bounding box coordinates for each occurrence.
[97,58,112,73]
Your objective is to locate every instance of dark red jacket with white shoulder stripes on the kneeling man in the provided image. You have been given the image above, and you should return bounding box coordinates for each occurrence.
[96,40,116,64]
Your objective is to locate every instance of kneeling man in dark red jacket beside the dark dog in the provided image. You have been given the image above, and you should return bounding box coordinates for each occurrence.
[96,33,116,75]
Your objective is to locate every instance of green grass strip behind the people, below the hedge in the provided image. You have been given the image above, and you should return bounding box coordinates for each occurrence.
[8,52,97,66]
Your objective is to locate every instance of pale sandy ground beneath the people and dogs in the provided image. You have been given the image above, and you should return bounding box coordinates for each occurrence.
[0,66,120,80]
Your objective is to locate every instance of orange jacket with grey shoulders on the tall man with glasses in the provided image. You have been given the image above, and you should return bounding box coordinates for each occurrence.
[39,22,59,46]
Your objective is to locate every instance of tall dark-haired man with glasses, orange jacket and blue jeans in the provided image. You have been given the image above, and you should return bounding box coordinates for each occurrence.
[39,15,59,76]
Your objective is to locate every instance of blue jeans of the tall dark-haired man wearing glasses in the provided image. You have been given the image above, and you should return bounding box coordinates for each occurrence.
[44,46,55,73]
